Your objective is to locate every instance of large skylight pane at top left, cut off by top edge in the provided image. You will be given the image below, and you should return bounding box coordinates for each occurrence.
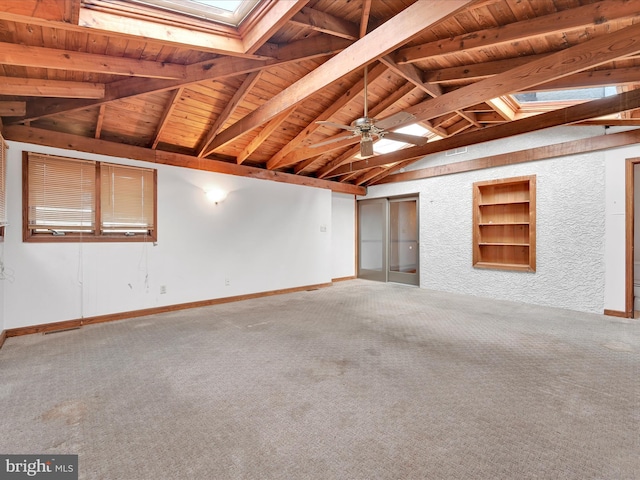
[131,0,260,27]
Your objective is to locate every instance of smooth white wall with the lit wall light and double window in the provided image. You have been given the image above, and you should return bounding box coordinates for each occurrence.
[4,142,355,329]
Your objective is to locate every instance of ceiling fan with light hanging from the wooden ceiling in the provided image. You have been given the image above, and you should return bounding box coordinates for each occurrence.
[311,66,428,158]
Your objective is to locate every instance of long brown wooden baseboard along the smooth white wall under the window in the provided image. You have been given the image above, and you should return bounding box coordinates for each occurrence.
[5,283,332,345]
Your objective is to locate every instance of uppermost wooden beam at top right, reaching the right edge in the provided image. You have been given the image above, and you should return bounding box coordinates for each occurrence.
[394,0,640,63]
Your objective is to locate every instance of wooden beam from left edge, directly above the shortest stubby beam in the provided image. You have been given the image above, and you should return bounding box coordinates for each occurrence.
[0,42,187,79]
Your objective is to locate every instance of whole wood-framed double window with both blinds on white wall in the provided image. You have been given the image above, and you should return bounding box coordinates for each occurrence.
[23,152,156,241]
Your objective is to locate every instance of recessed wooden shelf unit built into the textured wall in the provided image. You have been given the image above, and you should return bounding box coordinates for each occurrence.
[473,175,536,272]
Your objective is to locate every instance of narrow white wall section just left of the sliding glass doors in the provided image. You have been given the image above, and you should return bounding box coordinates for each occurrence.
[331,193,356,278]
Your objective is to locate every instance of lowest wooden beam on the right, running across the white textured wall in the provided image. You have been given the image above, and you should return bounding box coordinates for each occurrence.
[373,130,640,185]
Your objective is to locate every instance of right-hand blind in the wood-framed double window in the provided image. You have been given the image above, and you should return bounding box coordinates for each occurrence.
[100,163,155,232]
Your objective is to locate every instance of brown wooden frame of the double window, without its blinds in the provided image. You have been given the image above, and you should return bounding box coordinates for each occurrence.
[22,151,158,243]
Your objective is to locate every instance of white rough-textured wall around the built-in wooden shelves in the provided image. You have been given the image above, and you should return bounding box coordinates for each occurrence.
[367,129,605,313]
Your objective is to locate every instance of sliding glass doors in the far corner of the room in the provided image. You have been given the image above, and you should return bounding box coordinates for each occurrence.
[358,196,420,285]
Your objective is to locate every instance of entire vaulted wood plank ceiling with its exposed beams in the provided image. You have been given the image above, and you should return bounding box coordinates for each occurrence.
[0,0,640,193]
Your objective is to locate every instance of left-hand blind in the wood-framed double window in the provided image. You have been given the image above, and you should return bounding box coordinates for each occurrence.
[28,153,96,231]
